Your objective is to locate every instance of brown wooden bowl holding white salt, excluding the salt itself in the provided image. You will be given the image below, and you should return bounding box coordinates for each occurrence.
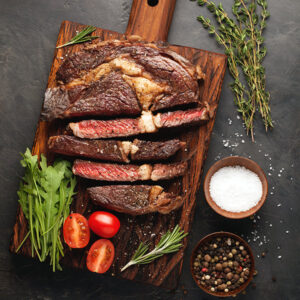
[204,156,268,219]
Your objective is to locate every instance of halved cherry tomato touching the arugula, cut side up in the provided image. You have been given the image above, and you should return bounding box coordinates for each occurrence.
[63,213,90,248]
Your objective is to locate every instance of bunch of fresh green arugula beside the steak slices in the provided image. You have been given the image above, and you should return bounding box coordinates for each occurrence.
[16,148,76,272]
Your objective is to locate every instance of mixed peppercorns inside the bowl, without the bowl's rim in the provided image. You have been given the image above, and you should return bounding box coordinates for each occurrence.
[193,237,251,293]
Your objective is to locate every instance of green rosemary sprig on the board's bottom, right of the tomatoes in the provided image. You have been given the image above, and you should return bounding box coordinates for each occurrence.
[121,225,188,272]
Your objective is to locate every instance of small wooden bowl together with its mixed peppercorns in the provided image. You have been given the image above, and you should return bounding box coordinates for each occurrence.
[190,232,254,297]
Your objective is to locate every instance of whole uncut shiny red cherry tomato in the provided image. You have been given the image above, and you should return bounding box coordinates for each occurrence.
[89,211,120,238]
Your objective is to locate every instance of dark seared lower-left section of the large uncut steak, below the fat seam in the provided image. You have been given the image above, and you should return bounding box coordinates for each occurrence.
[42,72,141,120]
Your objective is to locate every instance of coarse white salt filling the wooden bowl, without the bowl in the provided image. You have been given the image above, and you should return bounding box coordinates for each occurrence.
[209,166,263,212]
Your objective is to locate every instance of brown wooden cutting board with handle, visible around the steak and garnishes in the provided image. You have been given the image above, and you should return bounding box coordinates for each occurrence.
[10,0,226,289]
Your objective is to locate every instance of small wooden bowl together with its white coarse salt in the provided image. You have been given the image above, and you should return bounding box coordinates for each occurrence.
[204,156,268,219]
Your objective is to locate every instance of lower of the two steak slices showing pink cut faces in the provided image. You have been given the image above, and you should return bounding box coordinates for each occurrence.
[72,159,187,182]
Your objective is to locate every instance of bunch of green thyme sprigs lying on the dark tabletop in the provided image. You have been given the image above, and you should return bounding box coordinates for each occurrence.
[198,0,273,140]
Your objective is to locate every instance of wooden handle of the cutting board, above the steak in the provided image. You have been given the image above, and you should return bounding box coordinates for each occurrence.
[125,0,176,42]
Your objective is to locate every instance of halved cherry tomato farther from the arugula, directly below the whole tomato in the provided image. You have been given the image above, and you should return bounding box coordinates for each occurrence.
[86,239,115,273]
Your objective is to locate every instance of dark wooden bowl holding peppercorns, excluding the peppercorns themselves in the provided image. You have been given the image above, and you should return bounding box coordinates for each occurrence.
[190,232,255,297]
